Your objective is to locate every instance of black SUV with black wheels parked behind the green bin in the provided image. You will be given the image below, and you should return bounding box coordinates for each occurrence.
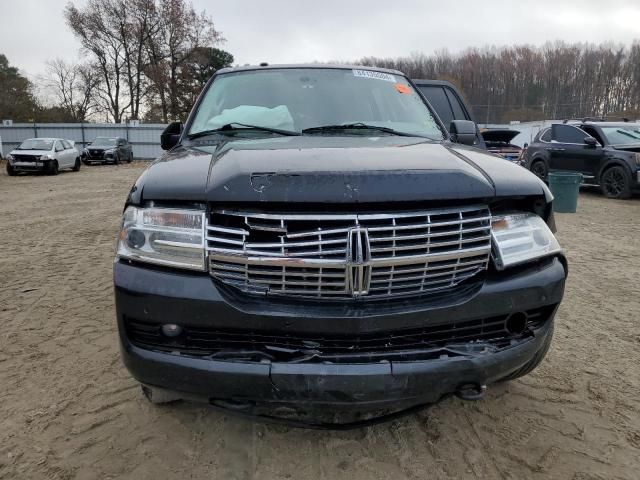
[525,120,640,198]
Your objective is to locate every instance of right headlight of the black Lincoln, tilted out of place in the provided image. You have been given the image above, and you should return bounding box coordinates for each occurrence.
[491,213,561,270]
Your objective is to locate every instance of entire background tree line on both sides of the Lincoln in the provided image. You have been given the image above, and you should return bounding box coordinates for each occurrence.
[0,20,640,123]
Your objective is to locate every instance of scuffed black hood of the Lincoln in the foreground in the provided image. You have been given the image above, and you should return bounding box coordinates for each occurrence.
[130,136,544,203]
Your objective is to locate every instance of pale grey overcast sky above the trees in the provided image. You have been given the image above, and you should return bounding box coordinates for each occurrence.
[0,0,640,78]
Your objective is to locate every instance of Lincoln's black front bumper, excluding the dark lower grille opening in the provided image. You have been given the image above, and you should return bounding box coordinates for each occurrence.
[114,257,566,411]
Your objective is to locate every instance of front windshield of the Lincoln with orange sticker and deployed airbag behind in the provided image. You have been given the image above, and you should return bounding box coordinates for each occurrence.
[188,68,443,140]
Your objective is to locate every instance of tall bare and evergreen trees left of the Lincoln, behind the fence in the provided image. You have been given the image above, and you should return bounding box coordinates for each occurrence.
[0,0,234,123]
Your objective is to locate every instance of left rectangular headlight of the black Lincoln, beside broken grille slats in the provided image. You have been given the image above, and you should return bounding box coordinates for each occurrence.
[116,207,205,271]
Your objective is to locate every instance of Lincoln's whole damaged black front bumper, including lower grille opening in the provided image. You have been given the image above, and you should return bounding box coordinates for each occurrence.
[114,257,566,411]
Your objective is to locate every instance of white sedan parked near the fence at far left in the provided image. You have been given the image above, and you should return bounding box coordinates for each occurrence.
[7,138,81,176]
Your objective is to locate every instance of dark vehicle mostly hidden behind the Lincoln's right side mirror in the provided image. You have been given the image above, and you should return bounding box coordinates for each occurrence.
[413,79,487,149]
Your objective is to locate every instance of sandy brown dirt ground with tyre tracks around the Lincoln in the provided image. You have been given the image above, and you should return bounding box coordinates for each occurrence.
[0,164,640,480]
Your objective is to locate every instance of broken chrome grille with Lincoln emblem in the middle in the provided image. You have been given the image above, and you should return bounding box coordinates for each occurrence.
[207,206,491,299]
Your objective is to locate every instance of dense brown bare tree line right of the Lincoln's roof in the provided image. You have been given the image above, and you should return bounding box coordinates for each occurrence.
[356,41,640,123]
